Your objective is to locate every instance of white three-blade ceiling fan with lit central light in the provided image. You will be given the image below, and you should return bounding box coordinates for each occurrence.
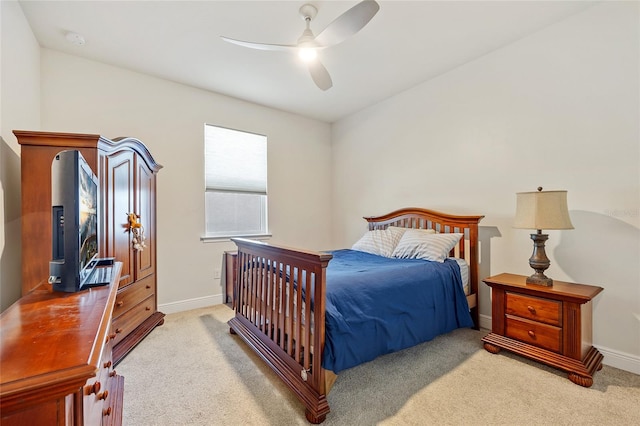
[221,0,380,90]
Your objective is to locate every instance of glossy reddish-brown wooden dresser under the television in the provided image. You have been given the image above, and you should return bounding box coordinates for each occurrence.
[0,262,124,426]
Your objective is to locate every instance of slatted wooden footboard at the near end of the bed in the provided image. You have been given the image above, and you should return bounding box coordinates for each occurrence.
[229,238,332,423]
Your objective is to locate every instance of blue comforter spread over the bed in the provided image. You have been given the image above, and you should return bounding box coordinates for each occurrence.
[322,249,473,373]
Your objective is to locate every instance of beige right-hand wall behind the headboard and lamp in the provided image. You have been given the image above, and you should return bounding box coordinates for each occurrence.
[332,3,640,373]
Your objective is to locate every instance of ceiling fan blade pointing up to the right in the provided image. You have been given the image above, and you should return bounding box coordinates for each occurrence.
[315,0,380,47]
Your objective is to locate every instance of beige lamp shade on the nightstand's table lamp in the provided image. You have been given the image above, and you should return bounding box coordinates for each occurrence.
[513,188,573,229]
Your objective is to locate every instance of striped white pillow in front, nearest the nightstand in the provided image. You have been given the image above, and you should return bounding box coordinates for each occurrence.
[392,229,462,263]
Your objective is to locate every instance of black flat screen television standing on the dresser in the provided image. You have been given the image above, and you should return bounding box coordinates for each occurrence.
[49,150,108,292]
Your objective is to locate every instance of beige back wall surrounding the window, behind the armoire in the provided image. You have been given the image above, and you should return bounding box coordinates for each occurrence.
[41,49,331,312]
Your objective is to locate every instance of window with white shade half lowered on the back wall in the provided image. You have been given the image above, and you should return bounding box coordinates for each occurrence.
[204,124,268,238]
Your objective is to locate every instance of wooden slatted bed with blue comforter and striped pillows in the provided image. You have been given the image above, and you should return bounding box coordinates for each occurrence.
[229,208,483,424]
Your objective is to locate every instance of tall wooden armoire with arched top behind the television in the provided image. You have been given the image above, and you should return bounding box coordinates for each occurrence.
[13,130,164,364]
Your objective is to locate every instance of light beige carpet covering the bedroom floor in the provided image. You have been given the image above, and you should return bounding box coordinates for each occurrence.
[117,305,640,426]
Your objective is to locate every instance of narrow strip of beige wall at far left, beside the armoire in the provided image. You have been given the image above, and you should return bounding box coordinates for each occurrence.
[0,1,40,311]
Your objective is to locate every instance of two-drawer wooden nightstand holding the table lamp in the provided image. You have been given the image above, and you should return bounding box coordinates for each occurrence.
[482,274,603,387]
